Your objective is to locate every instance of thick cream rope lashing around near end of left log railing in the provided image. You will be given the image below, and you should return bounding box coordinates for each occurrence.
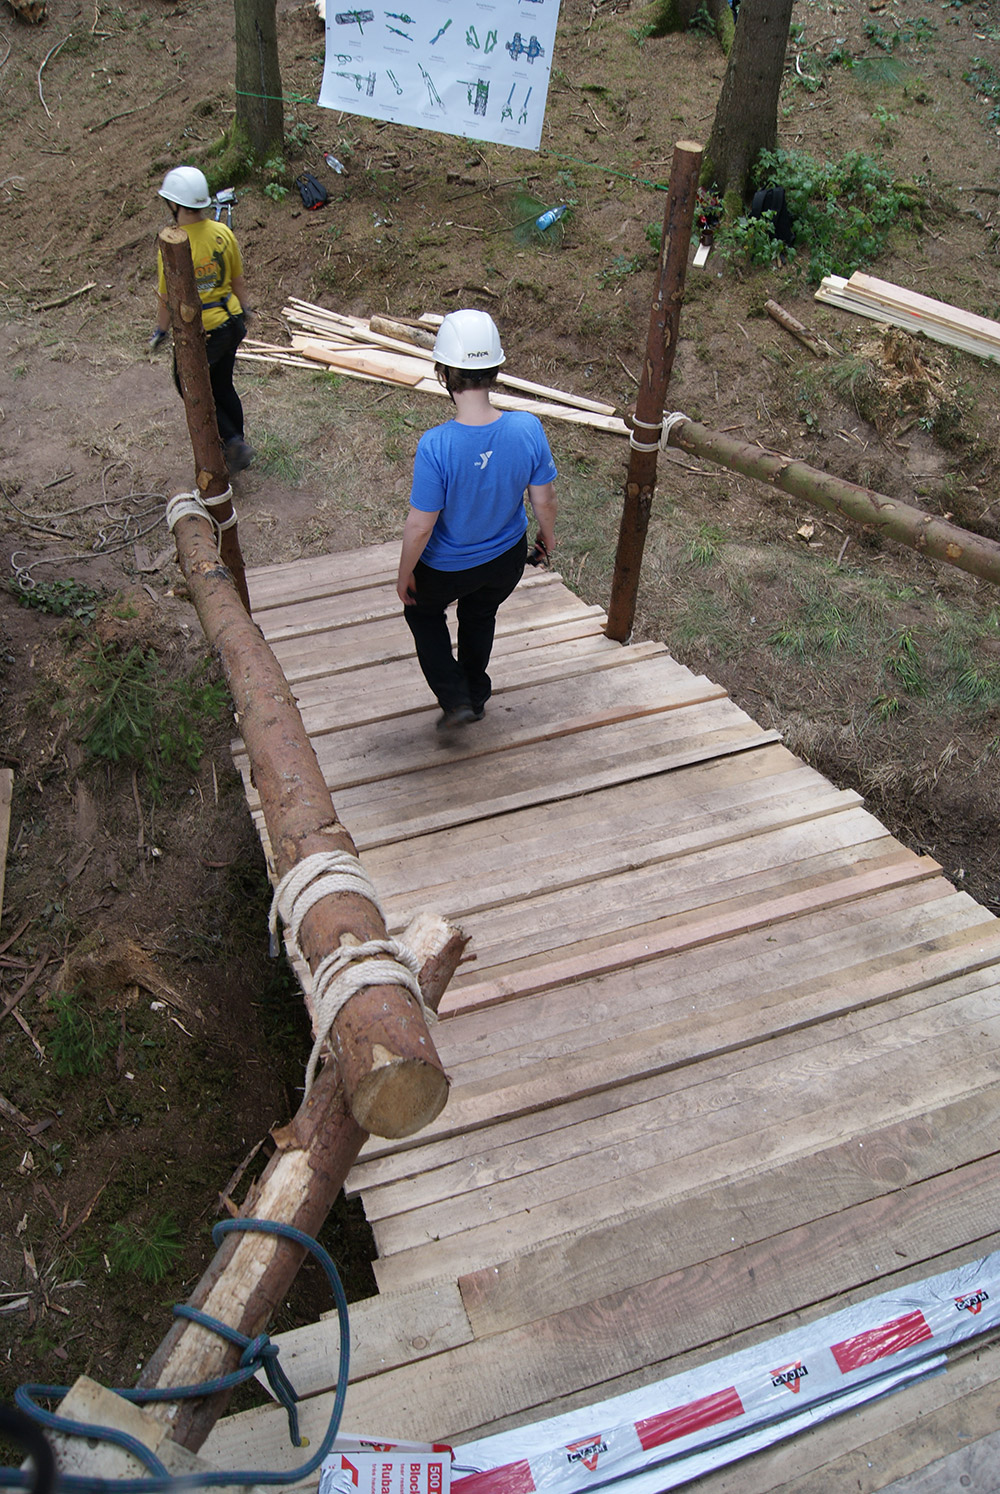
[269,850,436,1097]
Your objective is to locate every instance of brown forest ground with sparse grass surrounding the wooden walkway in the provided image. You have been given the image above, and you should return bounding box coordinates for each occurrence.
[0,0,1000,1446]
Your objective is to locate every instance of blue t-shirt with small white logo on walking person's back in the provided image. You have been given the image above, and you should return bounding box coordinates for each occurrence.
[410,409,556,571]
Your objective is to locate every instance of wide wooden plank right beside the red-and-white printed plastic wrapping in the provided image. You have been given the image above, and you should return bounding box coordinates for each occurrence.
[203,1158,1000,1461]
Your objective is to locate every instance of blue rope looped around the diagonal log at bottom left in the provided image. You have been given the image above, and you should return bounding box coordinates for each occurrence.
[0,1219,351,1494]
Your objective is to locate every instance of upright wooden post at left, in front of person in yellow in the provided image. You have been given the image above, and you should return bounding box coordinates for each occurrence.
[160,227,250,613]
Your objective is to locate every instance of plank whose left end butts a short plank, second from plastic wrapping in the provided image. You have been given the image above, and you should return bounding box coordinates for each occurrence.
[459,1087,1000,1339]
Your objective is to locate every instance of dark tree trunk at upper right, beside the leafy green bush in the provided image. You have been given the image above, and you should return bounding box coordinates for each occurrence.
[701,0,794,203]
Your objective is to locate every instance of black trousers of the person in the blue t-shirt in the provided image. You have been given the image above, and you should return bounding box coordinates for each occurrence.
[402,538,528,711]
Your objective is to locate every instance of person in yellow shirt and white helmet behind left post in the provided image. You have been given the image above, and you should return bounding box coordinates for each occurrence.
[149,166,254,475]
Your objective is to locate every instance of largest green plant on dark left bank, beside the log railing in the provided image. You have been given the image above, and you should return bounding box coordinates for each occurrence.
[79,639,227,796]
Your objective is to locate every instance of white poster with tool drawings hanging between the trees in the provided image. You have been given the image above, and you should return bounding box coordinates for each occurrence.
[320,0,559,151]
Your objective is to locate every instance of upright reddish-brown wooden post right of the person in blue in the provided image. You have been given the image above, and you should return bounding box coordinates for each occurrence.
[604,140,701,644]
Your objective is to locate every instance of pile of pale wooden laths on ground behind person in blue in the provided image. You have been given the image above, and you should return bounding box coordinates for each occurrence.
[239,299,628,436]
